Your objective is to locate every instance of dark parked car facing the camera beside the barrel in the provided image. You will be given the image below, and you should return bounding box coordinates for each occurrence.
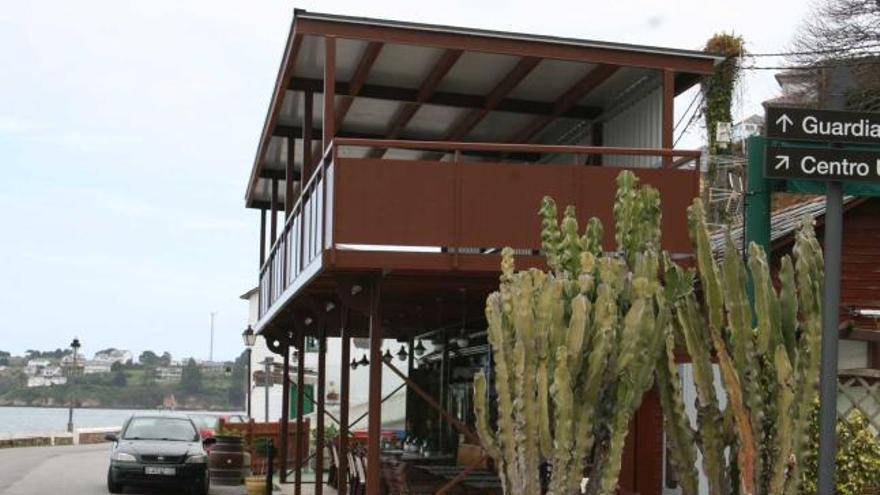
[106,414,215,495]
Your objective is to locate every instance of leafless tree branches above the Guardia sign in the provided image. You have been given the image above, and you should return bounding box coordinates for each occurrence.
[788,0,880,110]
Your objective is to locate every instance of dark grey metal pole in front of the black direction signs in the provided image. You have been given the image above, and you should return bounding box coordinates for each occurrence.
[818,66,849,495]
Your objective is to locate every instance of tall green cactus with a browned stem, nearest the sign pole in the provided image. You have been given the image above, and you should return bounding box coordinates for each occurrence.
[657,199,823,495]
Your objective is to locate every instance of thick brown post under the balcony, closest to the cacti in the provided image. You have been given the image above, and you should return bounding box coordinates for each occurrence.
[366,280,384,495]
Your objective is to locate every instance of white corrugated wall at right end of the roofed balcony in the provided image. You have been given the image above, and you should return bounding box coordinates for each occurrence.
[602,88,663,168]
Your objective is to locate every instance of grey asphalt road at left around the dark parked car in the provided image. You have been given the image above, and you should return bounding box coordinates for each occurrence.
[0,444,244,495]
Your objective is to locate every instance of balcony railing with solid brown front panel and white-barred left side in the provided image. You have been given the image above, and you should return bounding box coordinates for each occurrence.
[260,138,700,318]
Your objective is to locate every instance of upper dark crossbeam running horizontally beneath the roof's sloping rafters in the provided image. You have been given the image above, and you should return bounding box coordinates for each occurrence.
[287,77,602,119]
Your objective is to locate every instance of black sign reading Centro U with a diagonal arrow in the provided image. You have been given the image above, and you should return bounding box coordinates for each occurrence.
[764,146,880,182]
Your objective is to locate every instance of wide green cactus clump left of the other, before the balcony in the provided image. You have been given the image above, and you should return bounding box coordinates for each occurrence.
[474,172,672,495]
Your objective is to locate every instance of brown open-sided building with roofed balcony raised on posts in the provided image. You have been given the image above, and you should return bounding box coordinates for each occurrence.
[246,11,721,495]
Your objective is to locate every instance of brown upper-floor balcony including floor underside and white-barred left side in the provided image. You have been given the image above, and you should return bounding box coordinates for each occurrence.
[258,138,699,337]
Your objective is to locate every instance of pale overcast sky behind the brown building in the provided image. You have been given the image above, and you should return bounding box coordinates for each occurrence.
[0,0,809,358]
